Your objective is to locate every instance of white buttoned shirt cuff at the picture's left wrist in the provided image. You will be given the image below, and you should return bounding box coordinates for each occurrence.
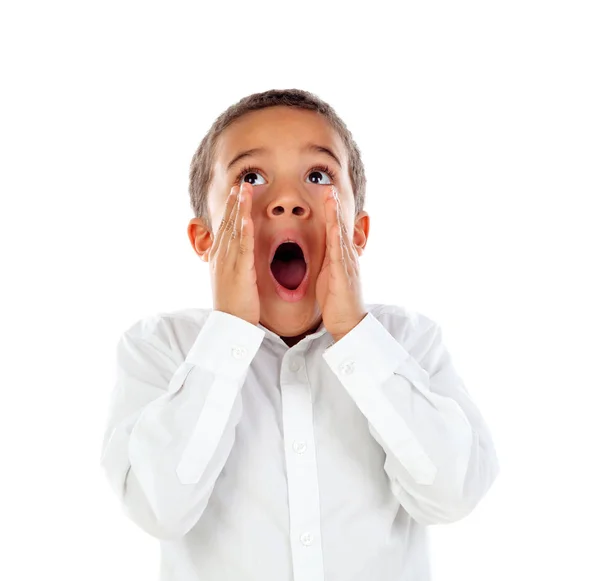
[185,311,265,379]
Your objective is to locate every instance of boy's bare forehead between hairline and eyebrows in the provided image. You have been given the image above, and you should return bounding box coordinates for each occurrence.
[215,106,346,172]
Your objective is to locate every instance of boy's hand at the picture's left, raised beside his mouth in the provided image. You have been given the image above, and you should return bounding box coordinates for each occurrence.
[208,182,260,325]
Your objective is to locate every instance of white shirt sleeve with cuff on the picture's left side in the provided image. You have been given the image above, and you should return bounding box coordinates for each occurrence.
[101,311,264,539]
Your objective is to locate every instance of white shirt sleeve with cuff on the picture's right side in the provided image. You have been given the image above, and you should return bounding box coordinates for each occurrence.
[323,313,499,525]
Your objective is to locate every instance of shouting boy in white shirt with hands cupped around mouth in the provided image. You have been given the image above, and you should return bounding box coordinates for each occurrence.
[102,90,499,581]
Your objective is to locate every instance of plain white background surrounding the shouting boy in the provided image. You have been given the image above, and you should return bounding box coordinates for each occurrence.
[0,0,600,581]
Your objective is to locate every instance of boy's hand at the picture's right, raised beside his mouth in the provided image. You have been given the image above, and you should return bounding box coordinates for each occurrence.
[316,187,367,341]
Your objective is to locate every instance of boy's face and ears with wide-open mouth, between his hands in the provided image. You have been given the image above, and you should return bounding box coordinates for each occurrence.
[188,106,369,337]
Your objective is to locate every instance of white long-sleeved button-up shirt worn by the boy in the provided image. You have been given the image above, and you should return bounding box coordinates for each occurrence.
[101,305,499,581]
